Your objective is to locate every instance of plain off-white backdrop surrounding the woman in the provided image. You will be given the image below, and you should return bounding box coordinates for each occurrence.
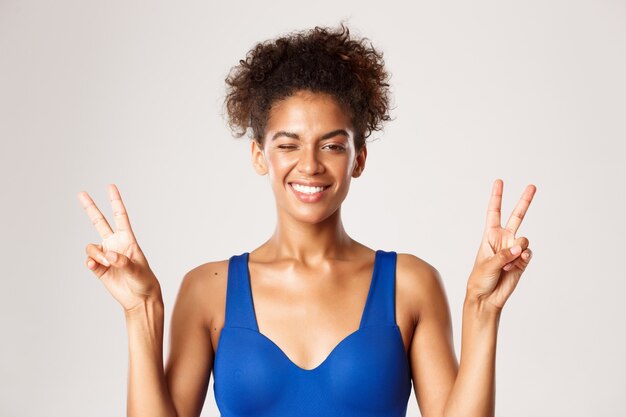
[0,0,626,417]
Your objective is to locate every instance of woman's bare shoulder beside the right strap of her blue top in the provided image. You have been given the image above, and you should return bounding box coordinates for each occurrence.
[396,253,447,321]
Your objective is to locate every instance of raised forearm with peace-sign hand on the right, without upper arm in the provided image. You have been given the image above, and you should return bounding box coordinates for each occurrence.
[444,179,536,417]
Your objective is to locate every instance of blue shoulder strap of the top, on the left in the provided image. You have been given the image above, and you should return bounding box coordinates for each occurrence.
[224,252,258,331]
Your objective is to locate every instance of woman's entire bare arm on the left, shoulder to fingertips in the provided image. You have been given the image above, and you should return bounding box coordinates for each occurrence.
[77,184,217,417]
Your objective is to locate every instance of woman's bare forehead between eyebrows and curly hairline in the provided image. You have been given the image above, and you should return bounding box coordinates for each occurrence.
[266,91,351,132]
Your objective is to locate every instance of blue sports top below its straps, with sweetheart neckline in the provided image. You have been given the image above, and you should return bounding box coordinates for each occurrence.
[213,326,411,417]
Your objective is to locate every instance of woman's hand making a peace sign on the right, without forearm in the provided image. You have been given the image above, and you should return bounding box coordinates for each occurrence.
[467,179,537,311]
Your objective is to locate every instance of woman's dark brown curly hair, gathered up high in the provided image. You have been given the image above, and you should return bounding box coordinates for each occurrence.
[224,23,391,151]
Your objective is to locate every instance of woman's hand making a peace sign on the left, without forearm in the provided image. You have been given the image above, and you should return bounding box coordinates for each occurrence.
[78,184,162,312]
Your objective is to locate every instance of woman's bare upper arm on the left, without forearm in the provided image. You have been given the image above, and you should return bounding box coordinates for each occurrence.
[165,267,213,417]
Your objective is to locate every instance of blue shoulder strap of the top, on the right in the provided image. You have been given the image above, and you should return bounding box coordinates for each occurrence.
[360,250,397,327]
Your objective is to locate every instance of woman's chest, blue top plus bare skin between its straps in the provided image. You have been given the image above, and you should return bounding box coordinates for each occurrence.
[207,251,411,416]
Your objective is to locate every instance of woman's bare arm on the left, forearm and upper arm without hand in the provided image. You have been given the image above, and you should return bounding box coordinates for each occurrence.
[126,268,213,417]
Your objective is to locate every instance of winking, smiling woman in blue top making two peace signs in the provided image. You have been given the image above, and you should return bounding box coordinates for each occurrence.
[78,25,536,417]
